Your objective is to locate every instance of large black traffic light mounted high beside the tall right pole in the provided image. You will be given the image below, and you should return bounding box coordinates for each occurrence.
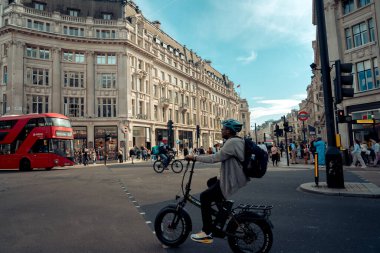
[334,60,354,104]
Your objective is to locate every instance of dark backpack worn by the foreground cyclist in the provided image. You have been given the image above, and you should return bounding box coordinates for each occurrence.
[241,138,268,178]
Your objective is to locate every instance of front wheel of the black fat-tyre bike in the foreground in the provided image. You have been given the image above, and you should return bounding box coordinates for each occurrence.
[154,205,192,247]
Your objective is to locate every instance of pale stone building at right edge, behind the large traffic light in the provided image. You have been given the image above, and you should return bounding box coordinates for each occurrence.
[313,0,380,148]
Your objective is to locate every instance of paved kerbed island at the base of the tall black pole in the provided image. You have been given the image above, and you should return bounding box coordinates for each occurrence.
[298,182,380,198]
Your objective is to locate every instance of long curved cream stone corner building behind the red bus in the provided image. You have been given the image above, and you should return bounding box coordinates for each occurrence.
[0,0,245,158]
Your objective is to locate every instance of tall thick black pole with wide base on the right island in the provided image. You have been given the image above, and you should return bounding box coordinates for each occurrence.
[315,0,344,188]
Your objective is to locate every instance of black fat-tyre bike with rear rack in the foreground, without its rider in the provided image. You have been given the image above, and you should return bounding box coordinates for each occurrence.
[154,161,273,253]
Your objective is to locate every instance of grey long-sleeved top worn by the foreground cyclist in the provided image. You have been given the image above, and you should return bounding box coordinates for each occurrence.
[196,138,249,199]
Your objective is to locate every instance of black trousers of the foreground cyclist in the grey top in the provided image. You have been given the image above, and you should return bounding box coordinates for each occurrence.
[200,177,224,234]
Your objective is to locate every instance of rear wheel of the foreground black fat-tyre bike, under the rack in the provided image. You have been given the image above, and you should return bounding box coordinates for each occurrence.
[226,212,273,253]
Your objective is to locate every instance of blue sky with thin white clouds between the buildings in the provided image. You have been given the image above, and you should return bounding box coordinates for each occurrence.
[134,0,316,125]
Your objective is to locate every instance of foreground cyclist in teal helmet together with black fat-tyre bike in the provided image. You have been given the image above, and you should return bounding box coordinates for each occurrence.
[155,119,273,252]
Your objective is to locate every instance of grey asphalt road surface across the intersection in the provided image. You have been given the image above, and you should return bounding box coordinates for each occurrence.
[0,162,380,253]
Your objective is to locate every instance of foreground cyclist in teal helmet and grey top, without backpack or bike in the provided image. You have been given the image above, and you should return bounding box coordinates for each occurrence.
[186,119,249,243]
